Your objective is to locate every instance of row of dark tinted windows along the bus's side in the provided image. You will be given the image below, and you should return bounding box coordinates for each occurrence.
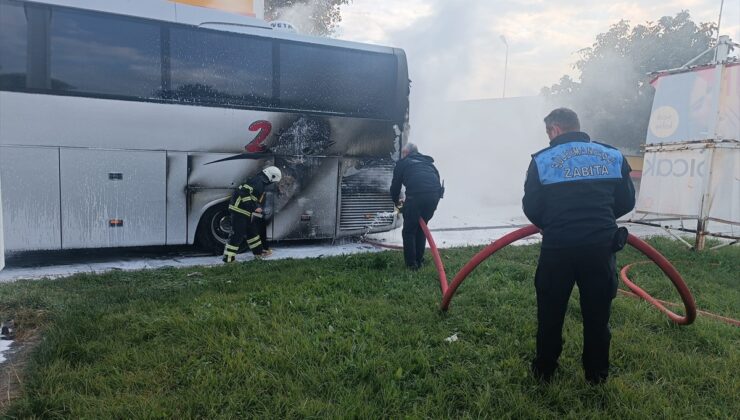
[0,0,399,118]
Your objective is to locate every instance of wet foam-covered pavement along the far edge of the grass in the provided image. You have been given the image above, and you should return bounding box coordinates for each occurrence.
[0,206,704,283]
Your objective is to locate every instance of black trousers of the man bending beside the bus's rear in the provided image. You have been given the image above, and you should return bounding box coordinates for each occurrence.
[401,192,439,268]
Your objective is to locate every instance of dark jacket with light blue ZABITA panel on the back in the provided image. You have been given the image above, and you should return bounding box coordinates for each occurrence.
[522,132,635,248]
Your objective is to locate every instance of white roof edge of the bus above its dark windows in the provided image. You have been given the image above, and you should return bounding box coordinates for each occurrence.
[21,0,394,54]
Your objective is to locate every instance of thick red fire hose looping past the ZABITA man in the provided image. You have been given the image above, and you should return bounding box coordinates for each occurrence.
[419,218,696,325]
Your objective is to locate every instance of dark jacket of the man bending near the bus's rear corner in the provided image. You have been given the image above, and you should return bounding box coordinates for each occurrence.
[391,152,441,203]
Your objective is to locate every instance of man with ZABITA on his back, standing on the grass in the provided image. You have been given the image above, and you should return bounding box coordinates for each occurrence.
[522,108,635,384]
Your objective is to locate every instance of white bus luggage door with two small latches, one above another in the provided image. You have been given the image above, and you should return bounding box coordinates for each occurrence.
[59,149,167,249]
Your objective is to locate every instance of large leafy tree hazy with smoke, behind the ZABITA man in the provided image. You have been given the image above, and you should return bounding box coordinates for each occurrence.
[541,10,717,152]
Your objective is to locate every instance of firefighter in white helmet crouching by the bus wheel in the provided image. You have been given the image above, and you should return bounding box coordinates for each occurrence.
[223,166,283,263]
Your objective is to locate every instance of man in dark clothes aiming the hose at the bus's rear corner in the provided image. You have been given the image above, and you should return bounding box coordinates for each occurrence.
[391,143,442,270]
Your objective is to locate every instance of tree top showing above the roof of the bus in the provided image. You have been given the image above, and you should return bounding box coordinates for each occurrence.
[265,0,351,36]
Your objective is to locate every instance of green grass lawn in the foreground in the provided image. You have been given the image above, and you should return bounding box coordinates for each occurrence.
[0,239,740,419]
